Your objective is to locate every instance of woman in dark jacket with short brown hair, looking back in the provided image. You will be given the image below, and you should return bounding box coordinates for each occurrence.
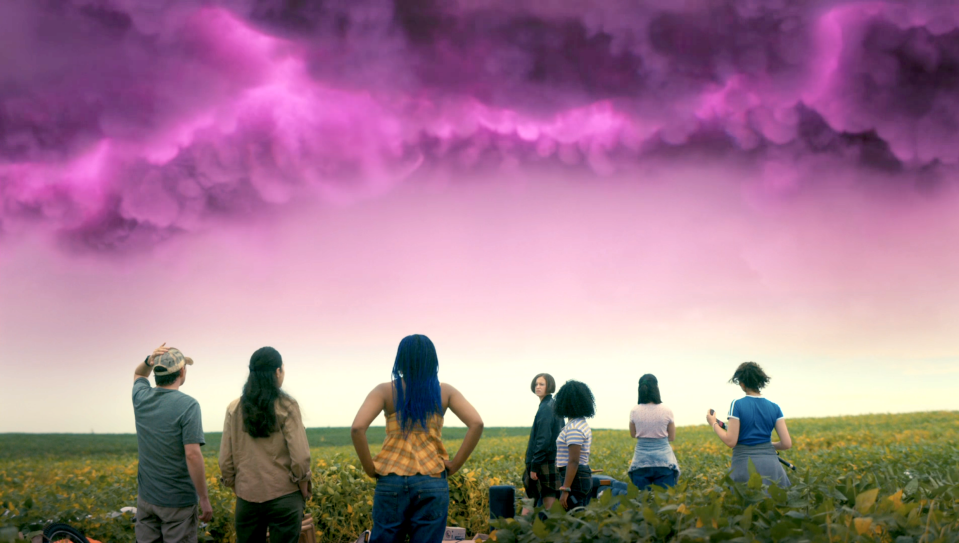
[523,373,563,515]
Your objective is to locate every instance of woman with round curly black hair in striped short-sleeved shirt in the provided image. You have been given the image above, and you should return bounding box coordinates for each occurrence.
[553,380,596,511]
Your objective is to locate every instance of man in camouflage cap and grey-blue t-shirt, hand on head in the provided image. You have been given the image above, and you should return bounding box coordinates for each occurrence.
[133,343,213,543]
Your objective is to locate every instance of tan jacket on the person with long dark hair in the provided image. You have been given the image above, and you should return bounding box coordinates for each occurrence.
[220,397,311,503]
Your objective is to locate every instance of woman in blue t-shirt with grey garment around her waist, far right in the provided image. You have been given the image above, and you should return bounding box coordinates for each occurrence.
[706,362,792,487]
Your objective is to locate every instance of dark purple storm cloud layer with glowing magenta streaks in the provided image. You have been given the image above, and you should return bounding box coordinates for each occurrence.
[0,0,959,252]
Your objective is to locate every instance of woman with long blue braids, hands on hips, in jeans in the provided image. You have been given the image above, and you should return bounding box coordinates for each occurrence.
[350,334,483,543]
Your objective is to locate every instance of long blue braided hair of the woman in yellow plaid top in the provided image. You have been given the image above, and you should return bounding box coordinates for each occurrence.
[393,334,443,435]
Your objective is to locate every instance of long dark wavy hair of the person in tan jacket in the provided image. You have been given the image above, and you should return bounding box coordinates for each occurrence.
[240,347,285,437]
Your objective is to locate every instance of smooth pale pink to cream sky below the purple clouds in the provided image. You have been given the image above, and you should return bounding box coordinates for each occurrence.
[0,165,959,432]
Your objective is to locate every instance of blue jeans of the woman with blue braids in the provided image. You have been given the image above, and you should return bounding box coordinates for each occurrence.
[370,472,450,543]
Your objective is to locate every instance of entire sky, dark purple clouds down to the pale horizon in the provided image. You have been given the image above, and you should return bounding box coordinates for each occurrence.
[0,0,959,432]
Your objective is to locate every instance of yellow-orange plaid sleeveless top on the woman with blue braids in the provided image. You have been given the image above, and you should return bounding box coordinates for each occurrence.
[373,413,450,477]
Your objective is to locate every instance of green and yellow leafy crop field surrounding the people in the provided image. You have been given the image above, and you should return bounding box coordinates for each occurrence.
[0,412,959,543]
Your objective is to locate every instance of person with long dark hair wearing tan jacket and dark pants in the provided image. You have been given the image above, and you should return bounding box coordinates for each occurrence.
[220,347,312,543]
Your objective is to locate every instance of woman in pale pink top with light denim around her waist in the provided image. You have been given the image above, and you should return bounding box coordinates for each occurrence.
[629,373,679,490]
